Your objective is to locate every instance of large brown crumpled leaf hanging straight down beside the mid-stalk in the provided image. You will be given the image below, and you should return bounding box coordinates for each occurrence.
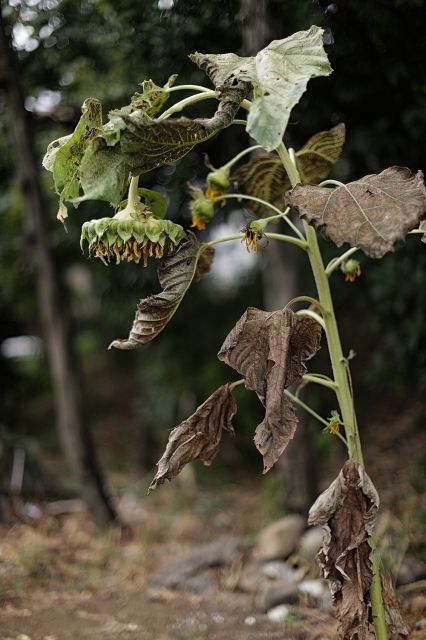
[218,307,321,473]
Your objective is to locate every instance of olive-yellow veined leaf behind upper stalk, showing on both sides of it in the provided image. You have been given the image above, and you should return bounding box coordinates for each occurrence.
[231,124,345,218]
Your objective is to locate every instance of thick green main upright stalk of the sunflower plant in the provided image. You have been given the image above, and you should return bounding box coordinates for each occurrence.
[277,143,388,640]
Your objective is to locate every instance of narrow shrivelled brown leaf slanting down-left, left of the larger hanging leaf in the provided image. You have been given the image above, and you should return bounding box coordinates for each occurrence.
[148,384,237,494]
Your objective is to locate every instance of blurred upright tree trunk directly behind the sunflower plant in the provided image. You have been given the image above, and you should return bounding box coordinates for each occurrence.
[241,0,318,514]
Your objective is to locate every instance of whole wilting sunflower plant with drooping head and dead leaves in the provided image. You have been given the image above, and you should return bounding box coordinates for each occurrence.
[44,26,426,640]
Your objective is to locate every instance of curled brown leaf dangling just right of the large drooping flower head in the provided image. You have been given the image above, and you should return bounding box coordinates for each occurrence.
[109,231,213,349]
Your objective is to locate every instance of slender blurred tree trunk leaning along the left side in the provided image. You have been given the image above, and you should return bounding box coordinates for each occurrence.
[0,14,116,526]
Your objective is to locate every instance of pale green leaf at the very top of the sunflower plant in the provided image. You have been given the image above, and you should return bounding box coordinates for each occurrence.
[192,26,332,151]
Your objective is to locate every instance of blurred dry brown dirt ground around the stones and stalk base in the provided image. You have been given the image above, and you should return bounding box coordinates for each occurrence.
[0,398,426,640]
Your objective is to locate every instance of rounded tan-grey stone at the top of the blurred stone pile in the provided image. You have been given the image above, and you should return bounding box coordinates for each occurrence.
[255,514,306,560]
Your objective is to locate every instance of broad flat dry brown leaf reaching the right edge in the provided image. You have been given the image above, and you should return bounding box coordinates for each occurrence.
[287,167,426,258]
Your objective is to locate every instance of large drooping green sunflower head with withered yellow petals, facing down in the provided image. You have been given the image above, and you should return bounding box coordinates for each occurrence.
[80,214,186,267]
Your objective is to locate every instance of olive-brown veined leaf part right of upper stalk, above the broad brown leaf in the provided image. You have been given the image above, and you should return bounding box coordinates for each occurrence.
[296,122,346,183]
